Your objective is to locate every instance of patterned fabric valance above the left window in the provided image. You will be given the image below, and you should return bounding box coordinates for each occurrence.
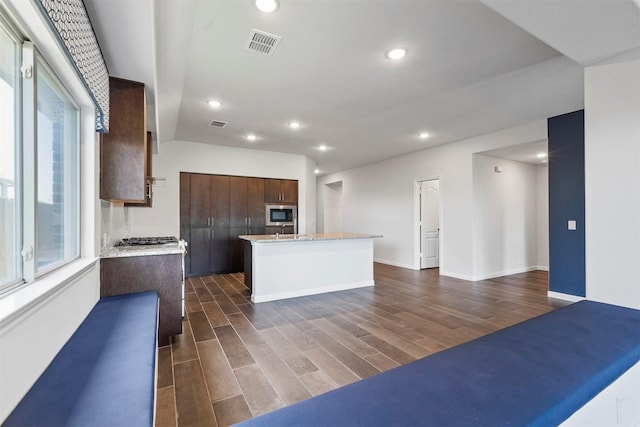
[36,0,109,133]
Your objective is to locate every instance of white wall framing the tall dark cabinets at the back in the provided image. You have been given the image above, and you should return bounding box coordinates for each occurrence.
[112,141,316,236]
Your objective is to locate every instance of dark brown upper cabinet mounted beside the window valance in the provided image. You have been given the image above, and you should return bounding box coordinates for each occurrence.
[100,77,151,206]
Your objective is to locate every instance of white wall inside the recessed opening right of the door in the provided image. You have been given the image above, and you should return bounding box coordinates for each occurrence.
[473,154,537,280]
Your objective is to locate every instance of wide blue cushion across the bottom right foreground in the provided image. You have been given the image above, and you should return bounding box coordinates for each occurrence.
[240,301,640,427]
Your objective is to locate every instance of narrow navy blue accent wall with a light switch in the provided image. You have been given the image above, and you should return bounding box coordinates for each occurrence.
[547,110,585,297]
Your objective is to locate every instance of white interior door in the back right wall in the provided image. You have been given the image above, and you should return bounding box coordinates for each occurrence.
[420,179,440,268]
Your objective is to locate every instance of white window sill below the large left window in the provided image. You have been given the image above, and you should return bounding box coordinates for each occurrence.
[0,258,98,330]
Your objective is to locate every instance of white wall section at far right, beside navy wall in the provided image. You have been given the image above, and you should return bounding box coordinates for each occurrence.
[585,60,640,309]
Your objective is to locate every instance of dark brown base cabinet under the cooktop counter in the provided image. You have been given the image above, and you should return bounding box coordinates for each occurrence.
[100,254,182,347]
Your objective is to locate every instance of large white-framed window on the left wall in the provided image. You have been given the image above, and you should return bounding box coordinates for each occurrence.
[0,17,80,293]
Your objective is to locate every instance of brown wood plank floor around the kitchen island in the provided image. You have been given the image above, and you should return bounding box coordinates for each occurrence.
[156,264,567,426]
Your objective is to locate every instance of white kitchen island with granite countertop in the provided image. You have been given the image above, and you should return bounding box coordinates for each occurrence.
[240,233,382,302]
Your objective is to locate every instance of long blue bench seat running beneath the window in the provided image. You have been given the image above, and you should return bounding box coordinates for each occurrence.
[3,292,158,427]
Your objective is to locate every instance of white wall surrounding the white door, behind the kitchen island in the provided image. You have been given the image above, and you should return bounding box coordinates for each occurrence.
[317,120,547,280]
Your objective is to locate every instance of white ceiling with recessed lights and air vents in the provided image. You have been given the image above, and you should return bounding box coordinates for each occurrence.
[85,0,640,173]
